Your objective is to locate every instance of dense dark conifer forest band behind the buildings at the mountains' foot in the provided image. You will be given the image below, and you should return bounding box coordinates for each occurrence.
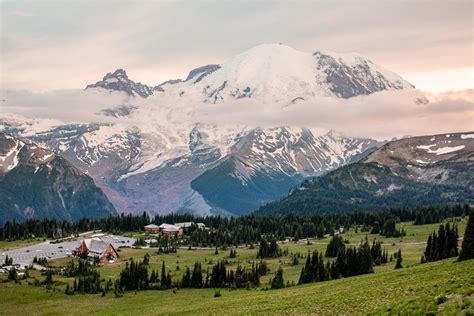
[0,205,470,247]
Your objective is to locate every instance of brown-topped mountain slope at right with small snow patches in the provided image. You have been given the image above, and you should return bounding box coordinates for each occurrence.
[256,133,474,214]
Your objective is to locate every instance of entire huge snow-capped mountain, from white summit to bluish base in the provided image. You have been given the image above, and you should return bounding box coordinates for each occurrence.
[0,44,413,214]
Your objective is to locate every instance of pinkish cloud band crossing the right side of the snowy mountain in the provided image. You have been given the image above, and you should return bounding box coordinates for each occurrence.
[193,91,474,139]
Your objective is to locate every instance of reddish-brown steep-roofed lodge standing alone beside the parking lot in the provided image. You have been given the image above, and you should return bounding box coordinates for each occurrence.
[72,238,119,264]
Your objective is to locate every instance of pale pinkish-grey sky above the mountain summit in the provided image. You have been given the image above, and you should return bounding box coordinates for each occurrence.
[0,0,474,93]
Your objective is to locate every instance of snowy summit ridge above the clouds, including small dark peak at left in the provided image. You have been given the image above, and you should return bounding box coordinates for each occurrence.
[87,44,413,104]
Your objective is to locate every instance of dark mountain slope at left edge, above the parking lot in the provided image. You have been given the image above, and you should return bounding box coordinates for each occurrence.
[0,133,116,223]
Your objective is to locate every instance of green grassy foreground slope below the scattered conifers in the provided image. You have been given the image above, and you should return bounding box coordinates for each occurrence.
[0,259,474,315]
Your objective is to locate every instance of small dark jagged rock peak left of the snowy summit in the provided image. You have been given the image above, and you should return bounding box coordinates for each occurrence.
[86,69,157,98]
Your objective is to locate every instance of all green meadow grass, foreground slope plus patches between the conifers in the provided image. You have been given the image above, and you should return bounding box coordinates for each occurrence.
[0,219,474,315]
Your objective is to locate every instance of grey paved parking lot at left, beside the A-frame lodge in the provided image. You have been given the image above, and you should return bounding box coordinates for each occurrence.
[0,235,135,267]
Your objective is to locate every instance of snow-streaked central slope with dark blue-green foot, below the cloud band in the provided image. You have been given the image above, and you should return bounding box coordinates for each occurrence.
[191,127,379,215]
